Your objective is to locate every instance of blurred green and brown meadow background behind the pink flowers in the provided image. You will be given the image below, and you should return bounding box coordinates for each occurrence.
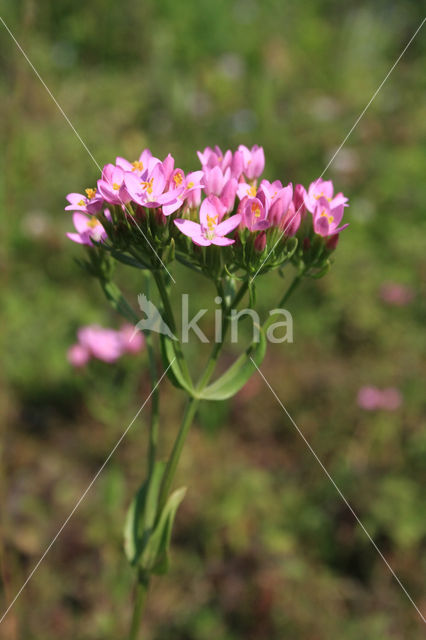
[0,0,426,640]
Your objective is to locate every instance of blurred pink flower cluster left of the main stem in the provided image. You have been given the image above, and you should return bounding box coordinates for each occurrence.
[67,324,144,368]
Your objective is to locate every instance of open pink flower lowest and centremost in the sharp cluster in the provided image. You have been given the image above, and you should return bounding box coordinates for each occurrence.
[174,196,241,247]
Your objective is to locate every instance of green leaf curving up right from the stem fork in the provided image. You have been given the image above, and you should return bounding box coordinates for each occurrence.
[199,327,266,400]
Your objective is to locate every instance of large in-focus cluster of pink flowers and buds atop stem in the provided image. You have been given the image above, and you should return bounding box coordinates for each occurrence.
[66,145,348,276]
